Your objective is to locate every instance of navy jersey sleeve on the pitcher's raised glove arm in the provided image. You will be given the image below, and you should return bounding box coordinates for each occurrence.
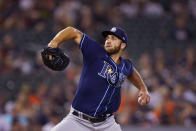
[79,34,105,60]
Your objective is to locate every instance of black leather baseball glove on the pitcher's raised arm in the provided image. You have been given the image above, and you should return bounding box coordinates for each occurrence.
[41,47,70,71]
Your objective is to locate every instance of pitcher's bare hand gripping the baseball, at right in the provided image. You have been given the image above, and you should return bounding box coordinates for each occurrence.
[138,90,150,105]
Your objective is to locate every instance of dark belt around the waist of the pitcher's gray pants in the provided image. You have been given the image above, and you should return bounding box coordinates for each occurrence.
[72,110,113,123]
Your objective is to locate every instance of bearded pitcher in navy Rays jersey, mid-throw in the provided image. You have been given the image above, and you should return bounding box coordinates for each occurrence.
[44,27,150,131]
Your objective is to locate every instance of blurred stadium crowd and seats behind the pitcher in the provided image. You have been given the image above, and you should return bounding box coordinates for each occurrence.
[0,0,196,131]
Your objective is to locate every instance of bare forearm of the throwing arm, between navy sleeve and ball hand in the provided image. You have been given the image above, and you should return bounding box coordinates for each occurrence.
[128,69,147,91]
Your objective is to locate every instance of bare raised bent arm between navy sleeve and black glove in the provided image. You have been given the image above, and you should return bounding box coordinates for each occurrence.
[48,27,82,48]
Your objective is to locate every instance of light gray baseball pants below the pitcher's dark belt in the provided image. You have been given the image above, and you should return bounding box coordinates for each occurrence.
[51,109,122,131]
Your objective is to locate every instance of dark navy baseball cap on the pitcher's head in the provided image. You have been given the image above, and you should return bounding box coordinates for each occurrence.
[102,27,128,44]
